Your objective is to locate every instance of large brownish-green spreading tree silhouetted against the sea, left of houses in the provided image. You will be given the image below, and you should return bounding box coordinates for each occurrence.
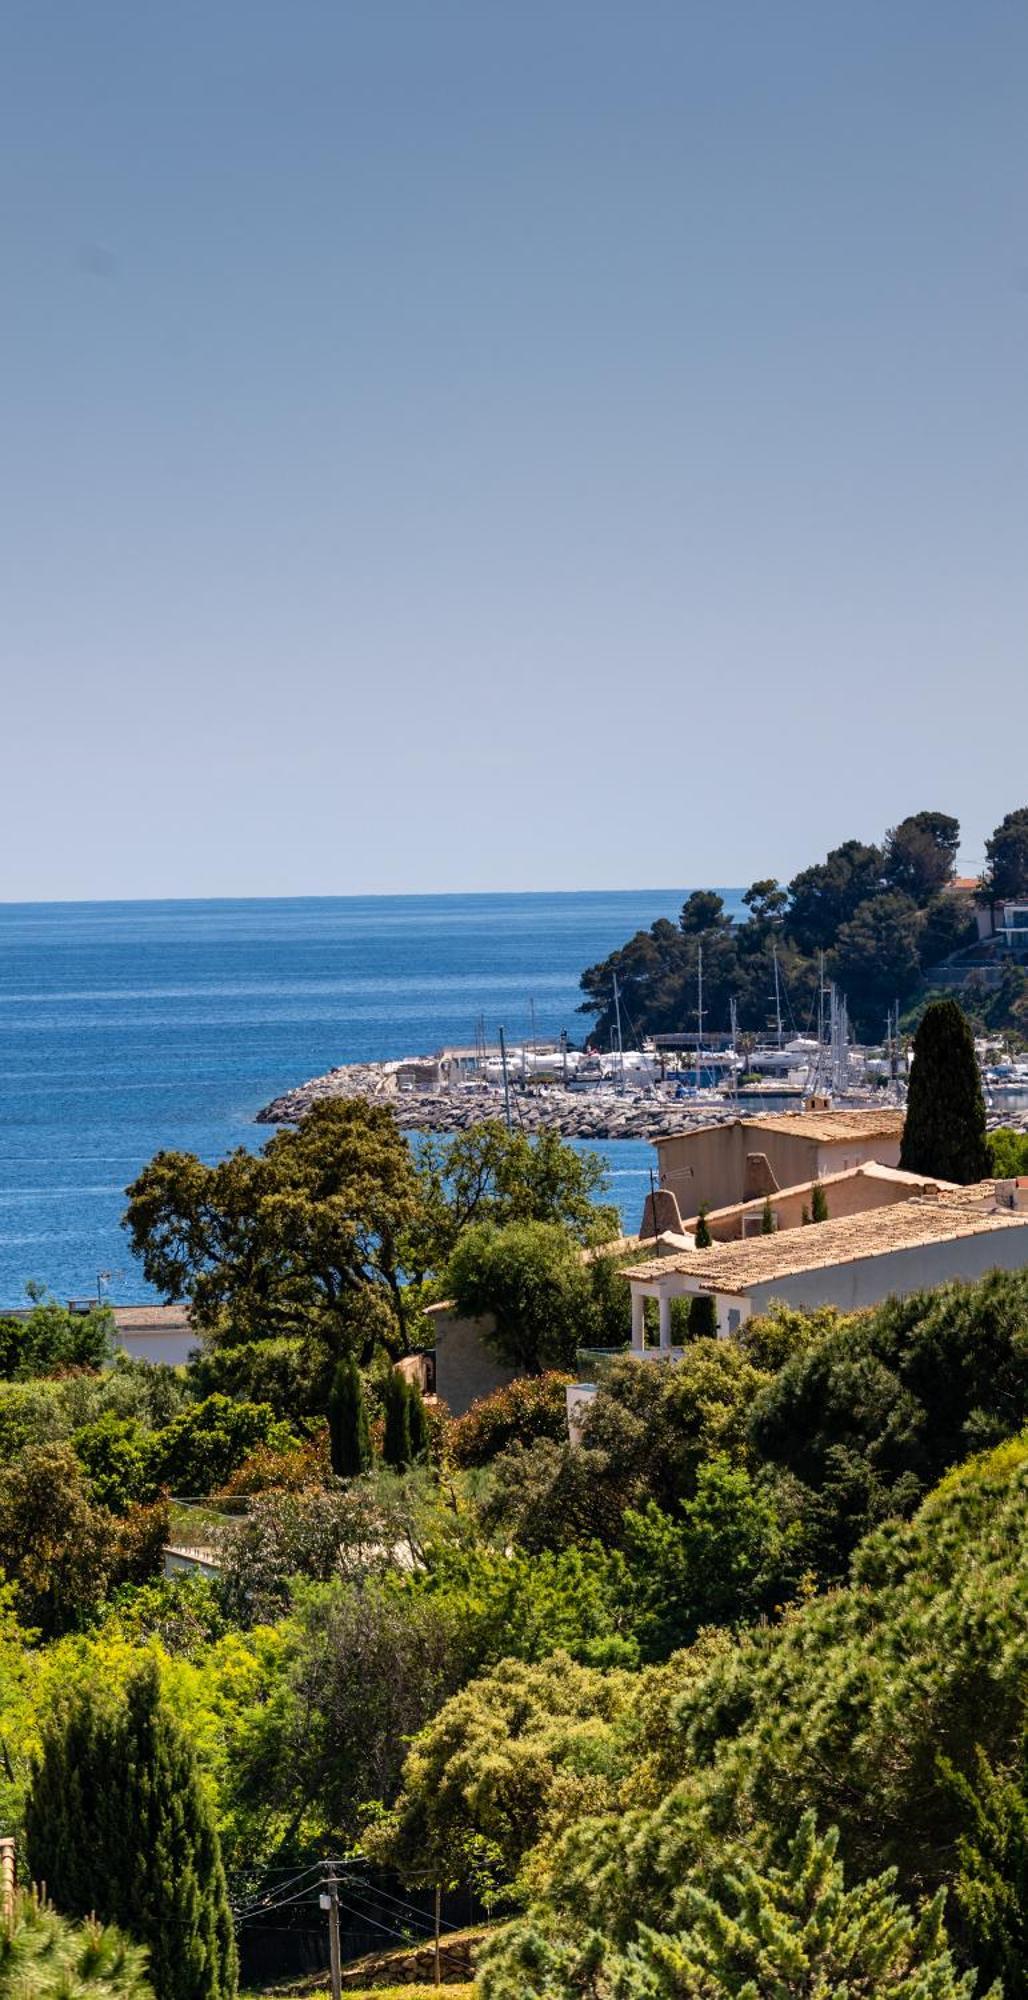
[124,1098,418,1360]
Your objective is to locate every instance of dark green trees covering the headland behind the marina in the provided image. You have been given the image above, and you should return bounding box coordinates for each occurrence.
[582,808,1028,1046]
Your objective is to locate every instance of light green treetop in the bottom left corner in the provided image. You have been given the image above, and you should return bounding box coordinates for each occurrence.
[0,1892,154,2000]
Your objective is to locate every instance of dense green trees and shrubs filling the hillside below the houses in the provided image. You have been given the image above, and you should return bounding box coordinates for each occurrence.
[0,1120,1028,2000]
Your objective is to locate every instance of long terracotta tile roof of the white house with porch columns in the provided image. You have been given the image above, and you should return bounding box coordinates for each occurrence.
[624,1182,1028,1296]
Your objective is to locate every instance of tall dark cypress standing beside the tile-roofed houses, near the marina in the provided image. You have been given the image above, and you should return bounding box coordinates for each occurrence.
[900,1000,990,1186]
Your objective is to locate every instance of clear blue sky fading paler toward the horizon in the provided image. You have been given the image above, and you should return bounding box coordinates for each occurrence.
[0,0,1028,900]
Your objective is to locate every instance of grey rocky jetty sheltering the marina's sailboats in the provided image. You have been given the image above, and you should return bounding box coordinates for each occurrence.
[258,1058,734,1140]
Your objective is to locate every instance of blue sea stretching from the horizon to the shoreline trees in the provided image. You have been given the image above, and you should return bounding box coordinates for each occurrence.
[0,890,738,1306]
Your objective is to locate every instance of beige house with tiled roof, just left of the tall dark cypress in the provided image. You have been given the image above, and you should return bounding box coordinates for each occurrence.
[654,1104,904,1216]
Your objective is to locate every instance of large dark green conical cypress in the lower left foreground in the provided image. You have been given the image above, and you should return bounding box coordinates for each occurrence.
[26,1660,236,2000]
